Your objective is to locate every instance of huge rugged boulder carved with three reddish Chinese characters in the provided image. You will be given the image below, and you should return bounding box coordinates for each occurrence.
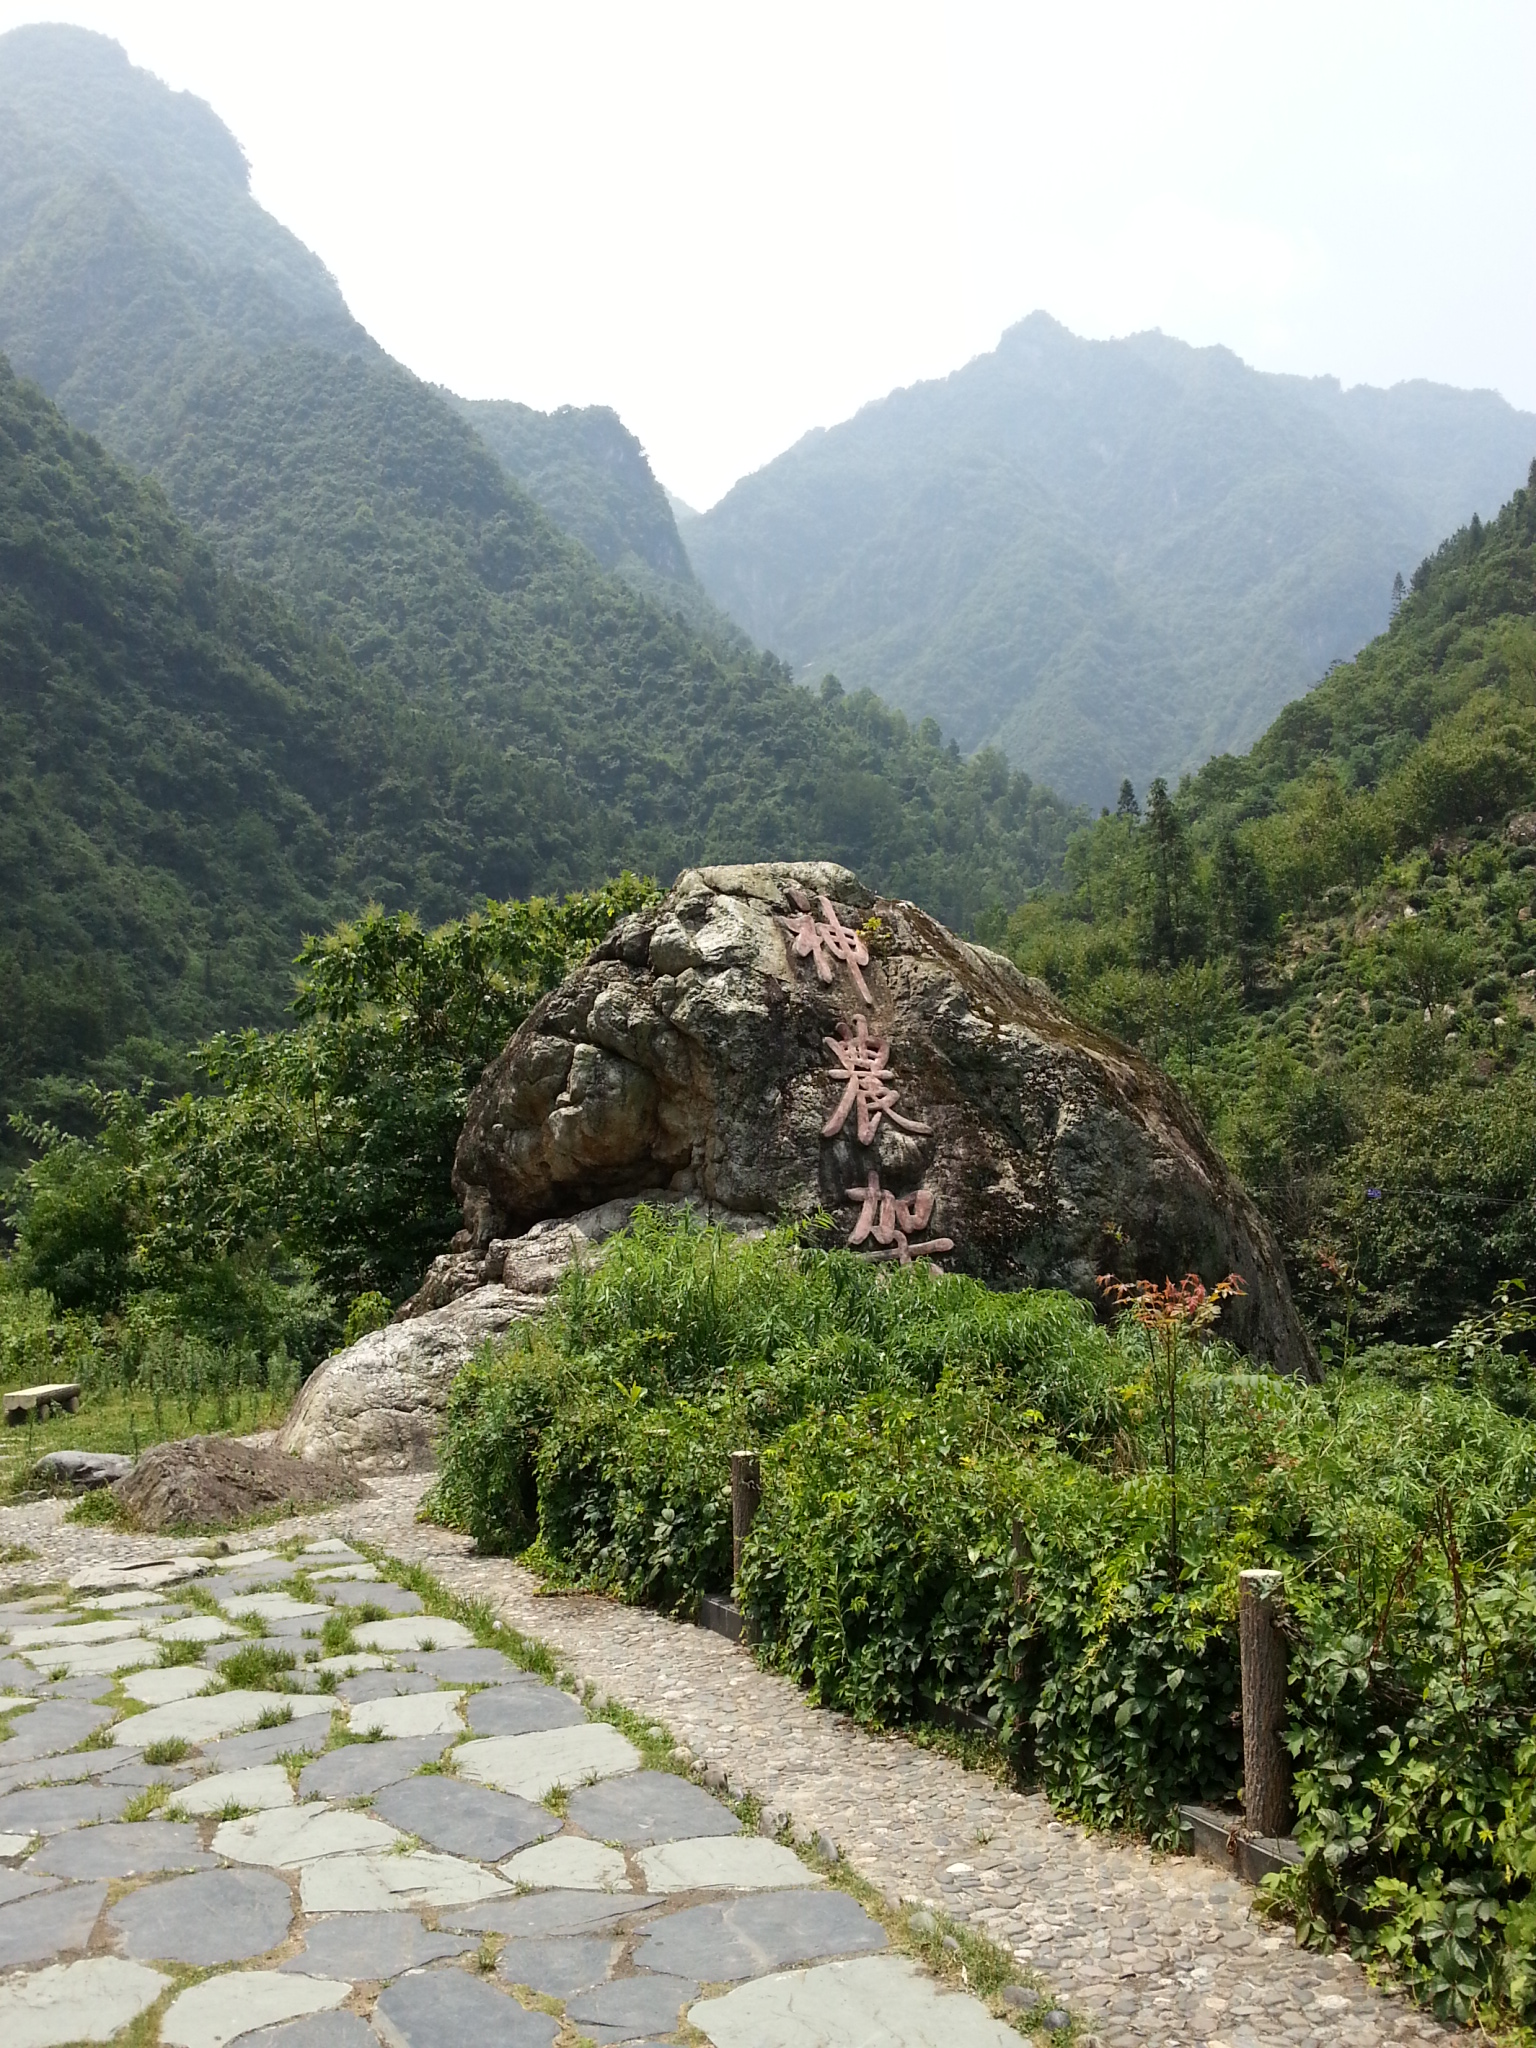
[454,862,1313,1386]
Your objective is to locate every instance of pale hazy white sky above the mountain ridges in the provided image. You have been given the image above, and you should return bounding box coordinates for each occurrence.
[0,0,1536,506]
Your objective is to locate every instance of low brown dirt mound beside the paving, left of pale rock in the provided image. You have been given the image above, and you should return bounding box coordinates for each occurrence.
[113,1436,369,1530]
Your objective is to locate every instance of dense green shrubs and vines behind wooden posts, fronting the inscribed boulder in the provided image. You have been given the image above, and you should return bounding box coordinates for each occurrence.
[432,1214,1536,2015]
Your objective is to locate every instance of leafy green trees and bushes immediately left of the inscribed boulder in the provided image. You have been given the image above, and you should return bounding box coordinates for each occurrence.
[0,877,649,1389]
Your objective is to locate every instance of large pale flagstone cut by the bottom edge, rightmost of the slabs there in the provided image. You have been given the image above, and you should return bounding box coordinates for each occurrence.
[688,1956,1018,2048]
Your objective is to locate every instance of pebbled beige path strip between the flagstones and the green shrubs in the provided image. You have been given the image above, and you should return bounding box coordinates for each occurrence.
[0,1481,1468,2048]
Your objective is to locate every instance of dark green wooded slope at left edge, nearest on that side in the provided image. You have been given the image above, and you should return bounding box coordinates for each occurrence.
[0,358,493,1112]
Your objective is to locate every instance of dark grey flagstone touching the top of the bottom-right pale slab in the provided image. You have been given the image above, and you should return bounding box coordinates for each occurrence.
[635,1888,887,1985]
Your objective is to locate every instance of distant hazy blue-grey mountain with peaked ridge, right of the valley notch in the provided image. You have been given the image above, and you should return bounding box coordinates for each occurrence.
[680,313,1536,803]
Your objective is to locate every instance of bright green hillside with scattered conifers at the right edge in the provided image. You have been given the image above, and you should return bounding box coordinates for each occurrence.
[1006,465,1536,1348]
